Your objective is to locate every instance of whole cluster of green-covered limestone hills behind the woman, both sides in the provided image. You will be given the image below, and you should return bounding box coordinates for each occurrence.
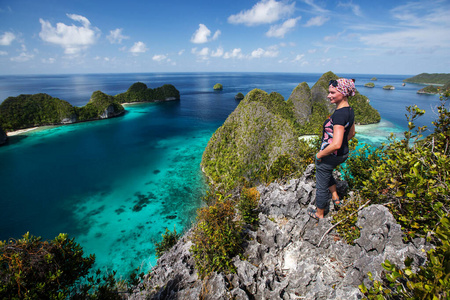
[201,72,380,190]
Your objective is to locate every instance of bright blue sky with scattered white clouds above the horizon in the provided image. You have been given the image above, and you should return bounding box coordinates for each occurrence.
[0,0,450,75]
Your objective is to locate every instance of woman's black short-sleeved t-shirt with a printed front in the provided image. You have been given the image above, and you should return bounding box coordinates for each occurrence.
[320,106,355,156]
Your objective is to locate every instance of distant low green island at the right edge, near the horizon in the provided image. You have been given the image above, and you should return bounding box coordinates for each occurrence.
[403,73,450,94]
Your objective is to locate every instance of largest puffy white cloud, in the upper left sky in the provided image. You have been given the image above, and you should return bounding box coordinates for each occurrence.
[39,14,100,54]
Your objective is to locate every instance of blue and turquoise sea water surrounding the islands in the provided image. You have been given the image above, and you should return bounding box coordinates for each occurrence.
[0,73,439,274]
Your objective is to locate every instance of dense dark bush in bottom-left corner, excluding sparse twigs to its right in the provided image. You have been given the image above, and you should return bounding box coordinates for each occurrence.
[0,233,95,299]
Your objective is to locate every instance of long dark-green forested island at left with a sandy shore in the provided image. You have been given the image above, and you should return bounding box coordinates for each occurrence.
[0,82,180,140]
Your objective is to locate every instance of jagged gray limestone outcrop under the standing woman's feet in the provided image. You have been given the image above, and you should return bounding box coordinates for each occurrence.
[129,165,430,300]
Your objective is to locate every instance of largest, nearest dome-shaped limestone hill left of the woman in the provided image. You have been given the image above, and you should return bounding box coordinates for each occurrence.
[201,89,298,188]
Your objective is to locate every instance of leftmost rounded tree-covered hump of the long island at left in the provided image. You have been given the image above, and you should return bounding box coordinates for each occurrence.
[0,94,76,131]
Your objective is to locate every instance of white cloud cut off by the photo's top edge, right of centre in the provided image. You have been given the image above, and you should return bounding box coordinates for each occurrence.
[228,0,295,26]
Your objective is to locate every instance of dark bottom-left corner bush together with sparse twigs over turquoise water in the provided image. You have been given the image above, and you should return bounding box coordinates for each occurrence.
[0,233,144,300]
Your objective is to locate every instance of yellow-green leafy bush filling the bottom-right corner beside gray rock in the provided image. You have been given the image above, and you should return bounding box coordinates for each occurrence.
[359,209,450,300]
